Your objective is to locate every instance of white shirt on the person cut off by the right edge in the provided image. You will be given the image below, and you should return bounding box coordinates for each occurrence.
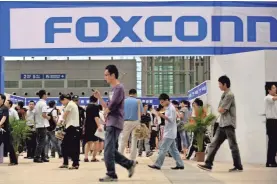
[265,94,277,119]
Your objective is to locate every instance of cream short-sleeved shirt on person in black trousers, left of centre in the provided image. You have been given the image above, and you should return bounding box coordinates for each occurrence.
[64,101,80,128]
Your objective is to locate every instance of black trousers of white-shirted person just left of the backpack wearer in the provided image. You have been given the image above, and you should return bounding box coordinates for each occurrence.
[35,128,47,159]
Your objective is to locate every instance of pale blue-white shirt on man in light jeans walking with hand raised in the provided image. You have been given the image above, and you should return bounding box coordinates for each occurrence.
[163,104,177,139]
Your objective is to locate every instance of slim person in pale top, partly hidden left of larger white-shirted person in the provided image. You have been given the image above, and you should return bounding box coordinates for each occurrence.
[25,100,37,159]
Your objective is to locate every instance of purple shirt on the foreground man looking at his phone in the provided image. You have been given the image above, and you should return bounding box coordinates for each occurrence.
[106,84,125,130]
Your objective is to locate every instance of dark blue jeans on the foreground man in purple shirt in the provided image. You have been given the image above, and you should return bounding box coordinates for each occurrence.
[104,126,133,177]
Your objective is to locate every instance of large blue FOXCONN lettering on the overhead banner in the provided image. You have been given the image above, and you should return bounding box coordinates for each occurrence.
[45,16,277,43]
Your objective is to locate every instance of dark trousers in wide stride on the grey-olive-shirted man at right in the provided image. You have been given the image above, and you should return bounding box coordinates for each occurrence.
[205,126,242,168]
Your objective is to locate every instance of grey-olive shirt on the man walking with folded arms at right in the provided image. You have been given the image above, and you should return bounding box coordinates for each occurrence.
[219,90,236,128]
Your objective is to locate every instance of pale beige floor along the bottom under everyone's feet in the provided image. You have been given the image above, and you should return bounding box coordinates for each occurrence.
[0,152,277,184]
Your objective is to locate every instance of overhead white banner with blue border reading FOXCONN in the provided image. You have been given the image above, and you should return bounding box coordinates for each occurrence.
[0,2,277,55]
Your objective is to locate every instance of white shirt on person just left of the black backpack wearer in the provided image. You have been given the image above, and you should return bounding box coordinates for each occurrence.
[35,99,49,128]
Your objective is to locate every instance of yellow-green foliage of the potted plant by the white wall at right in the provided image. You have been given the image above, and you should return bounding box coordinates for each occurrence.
[184,107,216,152]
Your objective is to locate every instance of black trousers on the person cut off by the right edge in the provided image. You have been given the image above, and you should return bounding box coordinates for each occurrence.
[266,119,277,164]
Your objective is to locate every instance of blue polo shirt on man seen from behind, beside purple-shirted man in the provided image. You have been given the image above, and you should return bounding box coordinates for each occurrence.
[124,97,143,121]
